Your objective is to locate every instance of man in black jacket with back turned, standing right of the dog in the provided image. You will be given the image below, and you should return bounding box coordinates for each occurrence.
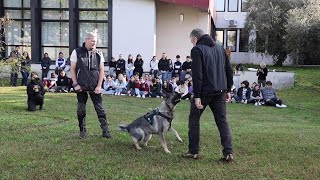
[182,29,233,162]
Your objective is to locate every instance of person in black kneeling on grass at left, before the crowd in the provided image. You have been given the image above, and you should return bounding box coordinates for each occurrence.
[27,72,45,111]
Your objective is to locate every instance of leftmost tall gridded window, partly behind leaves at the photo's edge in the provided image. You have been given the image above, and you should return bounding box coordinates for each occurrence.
[3,0,31,56]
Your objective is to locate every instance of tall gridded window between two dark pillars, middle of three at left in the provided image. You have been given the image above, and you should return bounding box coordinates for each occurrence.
[41,0,69,60]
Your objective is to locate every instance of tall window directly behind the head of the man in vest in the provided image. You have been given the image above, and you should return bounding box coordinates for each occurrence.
[78,0,108,61]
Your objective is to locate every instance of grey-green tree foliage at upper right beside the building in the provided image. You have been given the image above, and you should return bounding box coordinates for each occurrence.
[245,0,320,65]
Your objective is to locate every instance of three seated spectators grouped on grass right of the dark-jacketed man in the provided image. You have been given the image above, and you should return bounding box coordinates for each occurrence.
[231,81,287,108]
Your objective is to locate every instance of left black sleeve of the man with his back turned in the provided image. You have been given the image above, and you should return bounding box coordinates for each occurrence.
[191,47,203,98]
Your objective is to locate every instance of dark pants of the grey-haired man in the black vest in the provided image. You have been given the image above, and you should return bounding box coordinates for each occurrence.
[77,92,108,132]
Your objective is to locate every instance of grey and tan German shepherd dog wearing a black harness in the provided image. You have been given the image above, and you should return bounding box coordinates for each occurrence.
[119,93,183,154]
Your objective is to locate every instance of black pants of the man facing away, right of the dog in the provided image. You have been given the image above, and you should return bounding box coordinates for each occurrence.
[189,94,233,155]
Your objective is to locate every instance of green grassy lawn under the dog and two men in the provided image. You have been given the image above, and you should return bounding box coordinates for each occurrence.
[0,68,320,179]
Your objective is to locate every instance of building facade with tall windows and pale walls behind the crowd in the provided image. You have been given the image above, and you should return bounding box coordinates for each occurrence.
[0,0,280,71]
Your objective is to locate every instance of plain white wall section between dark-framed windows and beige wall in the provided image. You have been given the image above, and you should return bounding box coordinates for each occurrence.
[112,0,156,70]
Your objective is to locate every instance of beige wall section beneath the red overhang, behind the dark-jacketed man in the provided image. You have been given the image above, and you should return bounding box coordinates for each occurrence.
[156,2,210,61]
